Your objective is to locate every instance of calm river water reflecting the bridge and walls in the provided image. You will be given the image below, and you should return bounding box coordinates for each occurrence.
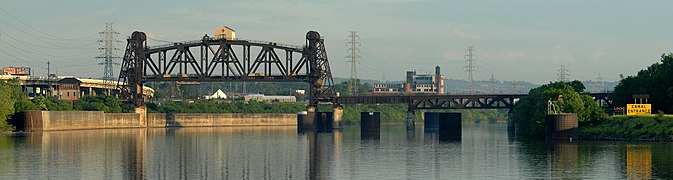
[0,124,673,179]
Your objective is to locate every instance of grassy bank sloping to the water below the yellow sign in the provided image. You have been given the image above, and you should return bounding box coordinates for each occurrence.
[580,114,673,141]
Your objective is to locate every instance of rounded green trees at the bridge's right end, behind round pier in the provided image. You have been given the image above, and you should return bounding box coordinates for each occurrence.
[512,81,607,137]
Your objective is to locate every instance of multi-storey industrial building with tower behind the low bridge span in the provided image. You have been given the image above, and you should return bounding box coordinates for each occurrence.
[372,66,444,95]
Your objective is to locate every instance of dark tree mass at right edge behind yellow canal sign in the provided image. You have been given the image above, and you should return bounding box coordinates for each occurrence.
[610,54,673,114]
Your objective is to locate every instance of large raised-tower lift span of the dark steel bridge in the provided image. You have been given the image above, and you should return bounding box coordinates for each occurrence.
[118,31,335,106]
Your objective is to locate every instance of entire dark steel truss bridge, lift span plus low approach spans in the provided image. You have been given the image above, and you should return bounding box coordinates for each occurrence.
[117,31,612,111]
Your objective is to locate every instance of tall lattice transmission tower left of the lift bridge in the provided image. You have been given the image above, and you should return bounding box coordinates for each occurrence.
[96,22,121,95]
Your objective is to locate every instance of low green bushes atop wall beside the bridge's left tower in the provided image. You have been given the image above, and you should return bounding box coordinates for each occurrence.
[78,95,128,113]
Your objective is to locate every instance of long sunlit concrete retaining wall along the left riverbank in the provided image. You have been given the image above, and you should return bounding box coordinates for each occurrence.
[17,111,297,131]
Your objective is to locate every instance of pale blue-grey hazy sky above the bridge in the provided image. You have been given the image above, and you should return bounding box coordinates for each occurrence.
[0,0,673,83]
